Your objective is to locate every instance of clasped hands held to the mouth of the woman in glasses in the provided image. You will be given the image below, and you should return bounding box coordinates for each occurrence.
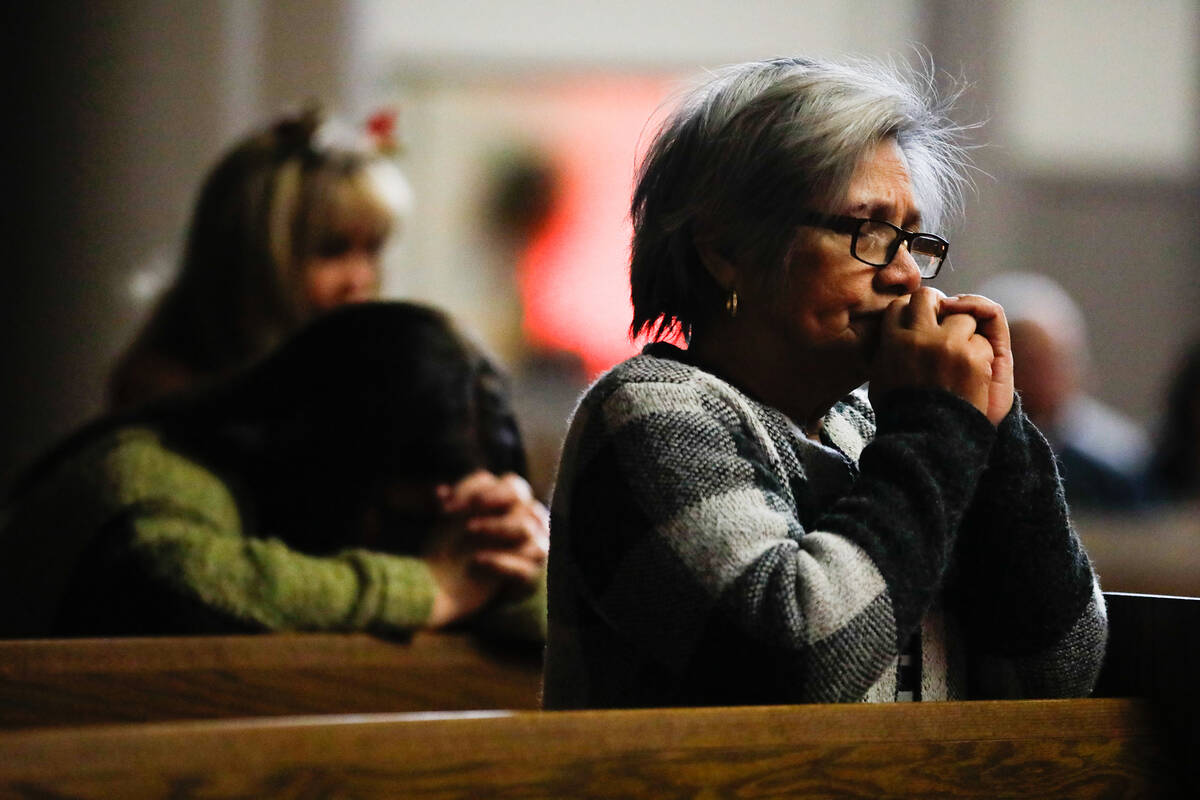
[870,287,1013,425]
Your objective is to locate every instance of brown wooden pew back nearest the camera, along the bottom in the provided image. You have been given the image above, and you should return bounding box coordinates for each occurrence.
[0,698,1180,800]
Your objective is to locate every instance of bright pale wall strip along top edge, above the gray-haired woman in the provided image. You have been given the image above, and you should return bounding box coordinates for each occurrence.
[355,0,922,72]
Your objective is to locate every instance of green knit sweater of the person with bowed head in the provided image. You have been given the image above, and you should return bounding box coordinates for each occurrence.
[0,427,545,639]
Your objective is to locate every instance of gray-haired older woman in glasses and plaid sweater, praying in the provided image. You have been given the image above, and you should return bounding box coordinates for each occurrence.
[545,59,1106,708]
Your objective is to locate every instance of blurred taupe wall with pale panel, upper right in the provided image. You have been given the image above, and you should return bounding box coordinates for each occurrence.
[924,0,1200,429]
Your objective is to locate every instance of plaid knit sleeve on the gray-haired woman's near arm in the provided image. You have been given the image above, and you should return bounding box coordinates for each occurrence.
[547,367,994,704]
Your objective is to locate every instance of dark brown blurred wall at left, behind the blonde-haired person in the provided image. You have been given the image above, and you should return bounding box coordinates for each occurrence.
[0,0,350,486]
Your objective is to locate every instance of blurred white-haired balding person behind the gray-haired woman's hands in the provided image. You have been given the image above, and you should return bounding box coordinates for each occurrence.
[979,272,1150,511]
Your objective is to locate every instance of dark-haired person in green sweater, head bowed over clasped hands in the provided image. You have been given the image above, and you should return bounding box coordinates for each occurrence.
[0,302,548,640]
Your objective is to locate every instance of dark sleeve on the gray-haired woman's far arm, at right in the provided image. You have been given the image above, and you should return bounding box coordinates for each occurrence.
[953,401,1108,698]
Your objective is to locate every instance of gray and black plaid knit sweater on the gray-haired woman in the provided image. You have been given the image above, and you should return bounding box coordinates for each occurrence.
[544,344,1106,708]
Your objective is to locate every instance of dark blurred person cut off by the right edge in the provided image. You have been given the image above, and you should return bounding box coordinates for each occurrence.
[1150,343,1200,503]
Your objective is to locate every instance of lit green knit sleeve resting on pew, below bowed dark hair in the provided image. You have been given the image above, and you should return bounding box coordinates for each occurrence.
[103,431,434,631]
